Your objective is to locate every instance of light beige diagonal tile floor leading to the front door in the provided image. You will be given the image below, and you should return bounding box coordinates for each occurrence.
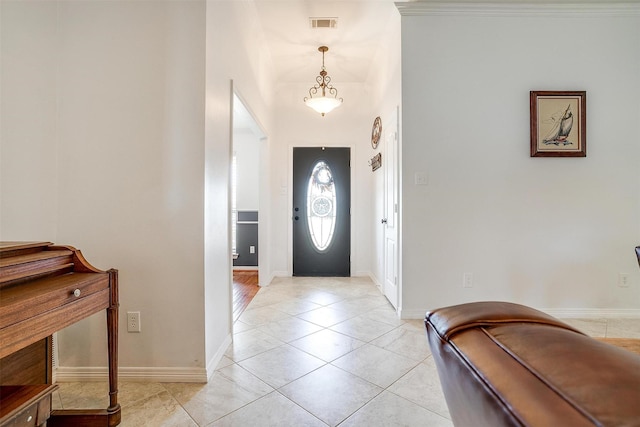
[54,277,640,427]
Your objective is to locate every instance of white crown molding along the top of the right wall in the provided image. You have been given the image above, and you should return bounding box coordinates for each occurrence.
[395,1,640,17]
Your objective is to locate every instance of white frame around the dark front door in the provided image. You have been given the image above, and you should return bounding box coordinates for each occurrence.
[287,143,357,277]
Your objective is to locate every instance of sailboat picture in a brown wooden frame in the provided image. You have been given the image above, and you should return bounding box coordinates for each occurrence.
[529,91,587,157]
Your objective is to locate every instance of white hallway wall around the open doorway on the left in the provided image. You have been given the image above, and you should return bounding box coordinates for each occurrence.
[204,0,273,369]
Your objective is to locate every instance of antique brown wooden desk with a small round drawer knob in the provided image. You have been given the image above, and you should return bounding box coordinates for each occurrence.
[0,242,120,427]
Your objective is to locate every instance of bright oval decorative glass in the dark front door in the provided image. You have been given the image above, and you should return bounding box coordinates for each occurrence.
[307,160,336,251]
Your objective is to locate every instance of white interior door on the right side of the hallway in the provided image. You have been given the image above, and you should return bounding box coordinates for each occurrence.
[382,110,399,309]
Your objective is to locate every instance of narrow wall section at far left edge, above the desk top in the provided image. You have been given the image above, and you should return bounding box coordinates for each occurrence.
[0,2,58,241]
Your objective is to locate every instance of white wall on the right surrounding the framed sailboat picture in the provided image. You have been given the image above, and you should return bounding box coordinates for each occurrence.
[401,4,640,317]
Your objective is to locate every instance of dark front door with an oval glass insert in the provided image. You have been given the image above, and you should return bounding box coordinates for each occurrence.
[292,147,351,276]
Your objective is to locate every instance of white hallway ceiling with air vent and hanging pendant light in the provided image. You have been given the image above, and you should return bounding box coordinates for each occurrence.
[255,0,399,85]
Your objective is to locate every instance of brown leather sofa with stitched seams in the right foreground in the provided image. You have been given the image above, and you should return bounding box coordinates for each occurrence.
[425,302,640,427]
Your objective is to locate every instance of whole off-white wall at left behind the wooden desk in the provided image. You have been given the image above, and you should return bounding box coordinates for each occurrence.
[2,1,216,379]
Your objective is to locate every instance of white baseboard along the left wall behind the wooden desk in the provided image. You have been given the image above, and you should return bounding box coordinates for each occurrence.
[56,366,207,383]
